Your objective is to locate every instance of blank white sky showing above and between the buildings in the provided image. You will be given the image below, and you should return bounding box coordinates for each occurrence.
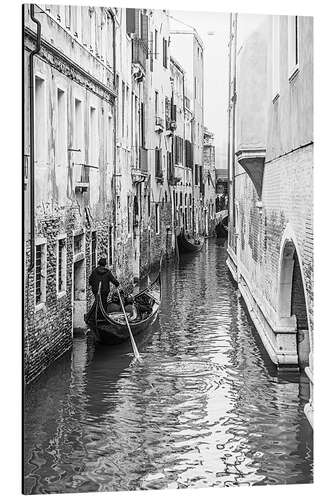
[169,11,263,168]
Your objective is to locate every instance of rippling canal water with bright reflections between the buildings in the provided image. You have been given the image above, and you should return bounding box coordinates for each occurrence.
[24,240,313,494]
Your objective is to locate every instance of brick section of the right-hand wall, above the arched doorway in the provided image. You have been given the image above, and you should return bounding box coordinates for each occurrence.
[236,145,313,340]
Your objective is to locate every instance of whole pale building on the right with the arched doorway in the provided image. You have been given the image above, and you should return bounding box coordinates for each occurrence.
[228,15,313,421]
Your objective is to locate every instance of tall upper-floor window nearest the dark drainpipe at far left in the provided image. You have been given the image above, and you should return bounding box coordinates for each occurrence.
[35,76,47,162]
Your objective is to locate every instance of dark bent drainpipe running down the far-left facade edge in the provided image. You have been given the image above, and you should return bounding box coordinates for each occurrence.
[28,3,41,271]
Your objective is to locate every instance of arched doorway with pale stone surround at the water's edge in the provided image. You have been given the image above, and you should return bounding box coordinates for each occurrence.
[279,238,310,369]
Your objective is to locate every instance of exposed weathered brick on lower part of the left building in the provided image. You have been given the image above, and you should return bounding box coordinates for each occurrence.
[24,203,115,383]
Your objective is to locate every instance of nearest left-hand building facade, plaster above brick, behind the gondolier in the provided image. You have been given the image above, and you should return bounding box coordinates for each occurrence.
[24,5,116,381]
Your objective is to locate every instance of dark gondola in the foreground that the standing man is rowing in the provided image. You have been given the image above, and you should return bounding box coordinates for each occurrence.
[84,272,161,345]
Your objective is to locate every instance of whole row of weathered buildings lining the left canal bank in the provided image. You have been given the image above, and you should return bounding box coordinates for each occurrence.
[23,5,209,382]
